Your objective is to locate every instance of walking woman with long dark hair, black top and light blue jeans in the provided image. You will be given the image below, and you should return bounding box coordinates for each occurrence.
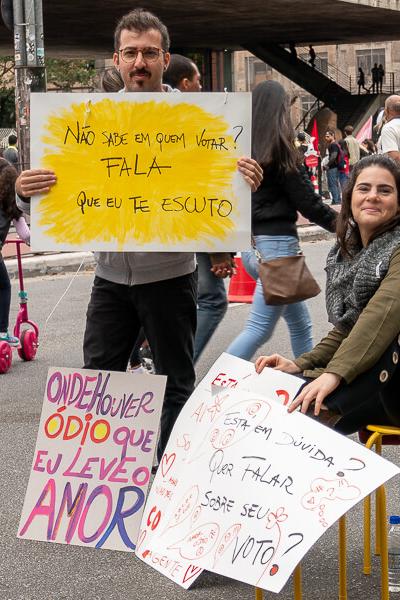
[227,81,337,360]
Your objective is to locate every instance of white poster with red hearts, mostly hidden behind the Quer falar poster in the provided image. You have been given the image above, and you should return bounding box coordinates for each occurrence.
[136,353,303,588]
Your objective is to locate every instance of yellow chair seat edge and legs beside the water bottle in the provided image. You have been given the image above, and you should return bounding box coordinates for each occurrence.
[359,425,400,600]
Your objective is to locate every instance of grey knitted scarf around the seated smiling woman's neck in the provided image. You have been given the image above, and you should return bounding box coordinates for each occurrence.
[325,226,400,333]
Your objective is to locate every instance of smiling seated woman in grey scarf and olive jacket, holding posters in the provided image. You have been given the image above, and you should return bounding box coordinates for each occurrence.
[256,155,400,434]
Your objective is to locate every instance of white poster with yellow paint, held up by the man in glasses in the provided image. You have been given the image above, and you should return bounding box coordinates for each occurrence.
[31,93,251,252]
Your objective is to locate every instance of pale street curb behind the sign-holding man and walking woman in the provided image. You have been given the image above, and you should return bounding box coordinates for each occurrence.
[5,225,335,279]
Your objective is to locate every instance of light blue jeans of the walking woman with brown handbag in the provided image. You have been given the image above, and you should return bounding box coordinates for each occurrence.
[227,235,313,360]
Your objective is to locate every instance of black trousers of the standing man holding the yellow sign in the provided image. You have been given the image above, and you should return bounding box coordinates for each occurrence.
[83,273,197,460]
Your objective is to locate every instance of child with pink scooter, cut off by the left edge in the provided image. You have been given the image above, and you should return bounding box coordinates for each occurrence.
[0,158,30,346]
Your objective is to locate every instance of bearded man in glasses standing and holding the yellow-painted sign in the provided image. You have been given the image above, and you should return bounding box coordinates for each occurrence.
[16,9,262,459]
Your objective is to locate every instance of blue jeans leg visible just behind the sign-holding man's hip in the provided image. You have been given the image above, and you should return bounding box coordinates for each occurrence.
[194,252,228,363]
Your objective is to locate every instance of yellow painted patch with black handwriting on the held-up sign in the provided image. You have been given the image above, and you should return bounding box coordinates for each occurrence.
[38,98,243,248]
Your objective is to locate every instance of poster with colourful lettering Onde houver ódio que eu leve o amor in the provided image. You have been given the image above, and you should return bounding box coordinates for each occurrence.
[18,367,166,552]
